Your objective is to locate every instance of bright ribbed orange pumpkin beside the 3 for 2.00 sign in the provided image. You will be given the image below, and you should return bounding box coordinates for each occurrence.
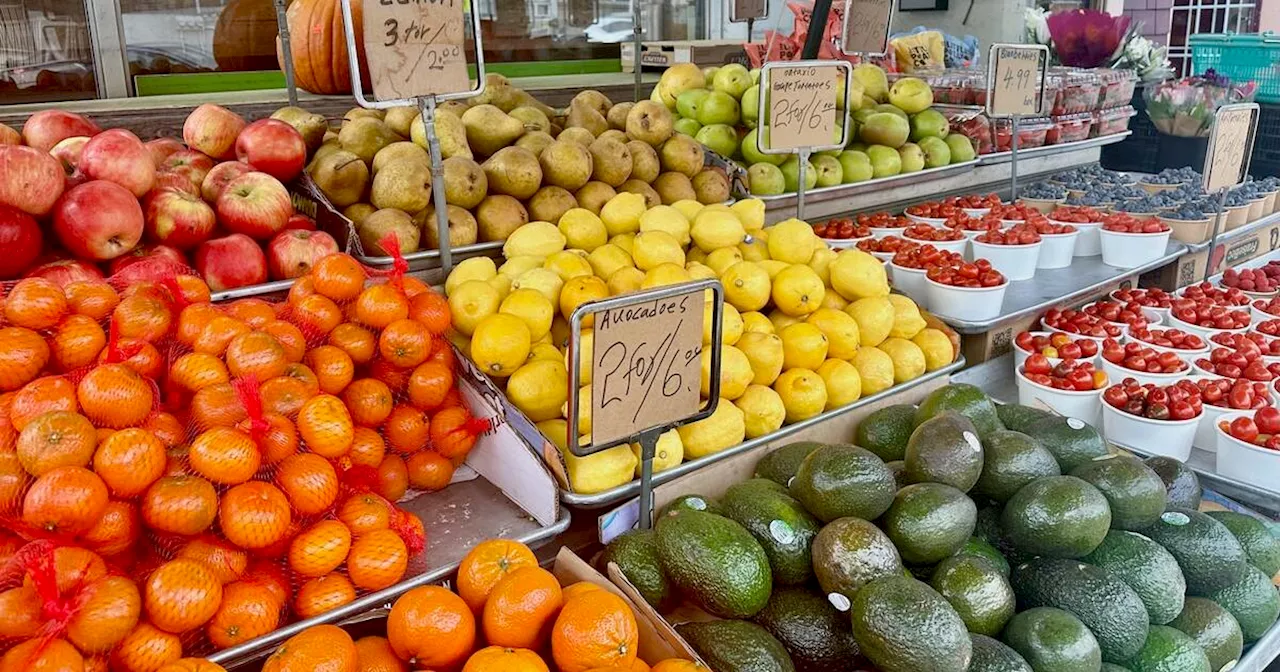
[275,0,370,95]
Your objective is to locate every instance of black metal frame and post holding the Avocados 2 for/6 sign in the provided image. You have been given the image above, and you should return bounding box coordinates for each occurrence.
[566,279,724,530]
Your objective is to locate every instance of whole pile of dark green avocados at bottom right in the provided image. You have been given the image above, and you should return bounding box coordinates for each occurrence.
[602,384,1280,672]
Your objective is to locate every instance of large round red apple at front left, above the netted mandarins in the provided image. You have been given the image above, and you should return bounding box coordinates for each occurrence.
[54,179,145,261]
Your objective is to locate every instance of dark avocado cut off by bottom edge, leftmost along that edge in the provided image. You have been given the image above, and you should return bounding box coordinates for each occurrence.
[676,620,795,672]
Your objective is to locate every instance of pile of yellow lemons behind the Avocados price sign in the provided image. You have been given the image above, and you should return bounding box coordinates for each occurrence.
[445,193,955,494]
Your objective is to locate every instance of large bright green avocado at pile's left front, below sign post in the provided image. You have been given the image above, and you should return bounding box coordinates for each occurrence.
[655,511,773,618]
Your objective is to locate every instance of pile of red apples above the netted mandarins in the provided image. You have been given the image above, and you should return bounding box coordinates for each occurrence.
[0,105,338,292]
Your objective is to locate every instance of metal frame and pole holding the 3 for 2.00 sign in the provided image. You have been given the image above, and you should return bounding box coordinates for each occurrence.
[335,0,485,274]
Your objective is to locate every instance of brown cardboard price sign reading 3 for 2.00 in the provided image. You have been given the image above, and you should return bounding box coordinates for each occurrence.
[364,0,471,100]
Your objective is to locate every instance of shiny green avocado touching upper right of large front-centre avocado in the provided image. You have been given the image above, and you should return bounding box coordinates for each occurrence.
[929,556,1015,636]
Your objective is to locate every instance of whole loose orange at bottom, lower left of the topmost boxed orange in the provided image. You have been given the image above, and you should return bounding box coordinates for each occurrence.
[387,586,476,669]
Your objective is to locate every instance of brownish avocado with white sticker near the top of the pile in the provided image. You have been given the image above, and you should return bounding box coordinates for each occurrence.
[902,412,982,493]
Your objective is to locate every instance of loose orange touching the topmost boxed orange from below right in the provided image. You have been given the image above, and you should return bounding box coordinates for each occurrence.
[483,567,564,649]
